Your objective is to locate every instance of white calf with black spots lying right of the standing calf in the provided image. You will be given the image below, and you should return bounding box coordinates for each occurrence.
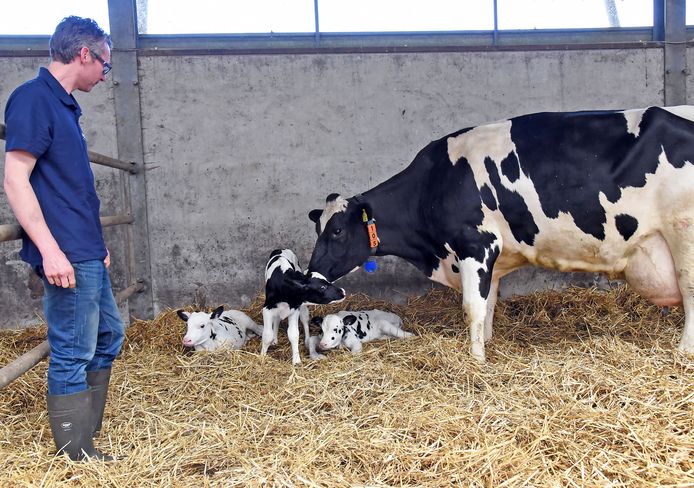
[308,310,414,359]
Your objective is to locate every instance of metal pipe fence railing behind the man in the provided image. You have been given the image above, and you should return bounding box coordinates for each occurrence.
[0,124,145,389]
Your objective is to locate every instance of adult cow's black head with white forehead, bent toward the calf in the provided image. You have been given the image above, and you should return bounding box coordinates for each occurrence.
[308,193,372,281]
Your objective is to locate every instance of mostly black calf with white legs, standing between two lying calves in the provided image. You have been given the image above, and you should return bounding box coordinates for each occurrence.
[260,249,345,364]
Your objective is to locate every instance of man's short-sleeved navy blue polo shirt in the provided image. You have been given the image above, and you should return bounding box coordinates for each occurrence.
[5,68,106,266]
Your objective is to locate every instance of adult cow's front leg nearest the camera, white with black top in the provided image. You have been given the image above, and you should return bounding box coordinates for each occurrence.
[460,232,501,363]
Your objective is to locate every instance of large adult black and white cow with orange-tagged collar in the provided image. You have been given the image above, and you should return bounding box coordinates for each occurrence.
[309,106,694,361]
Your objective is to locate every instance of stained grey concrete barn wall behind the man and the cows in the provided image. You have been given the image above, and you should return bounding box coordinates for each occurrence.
[0,49,676,326]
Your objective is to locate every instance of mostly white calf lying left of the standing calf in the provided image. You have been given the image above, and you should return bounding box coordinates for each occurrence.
[176,306,263,351]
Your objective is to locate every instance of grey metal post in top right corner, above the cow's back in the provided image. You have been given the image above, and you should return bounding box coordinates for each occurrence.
[664,0,688,106]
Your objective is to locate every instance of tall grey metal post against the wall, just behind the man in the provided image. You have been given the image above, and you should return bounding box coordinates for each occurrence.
[108,0,154,319]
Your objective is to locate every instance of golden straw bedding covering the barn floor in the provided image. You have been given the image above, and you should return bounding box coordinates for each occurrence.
[0,287,694,487]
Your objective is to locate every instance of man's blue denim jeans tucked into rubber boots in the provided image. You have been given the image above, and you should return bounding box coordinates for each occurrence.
[38,260,125,395]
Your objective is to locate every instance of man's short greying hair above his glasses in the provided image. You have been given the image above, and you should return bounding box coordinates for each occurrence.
[48,15,113,64]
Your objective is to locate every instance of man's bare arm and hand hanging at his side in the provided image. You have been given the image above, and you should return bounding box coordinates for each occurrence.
[4,151,75,288]
